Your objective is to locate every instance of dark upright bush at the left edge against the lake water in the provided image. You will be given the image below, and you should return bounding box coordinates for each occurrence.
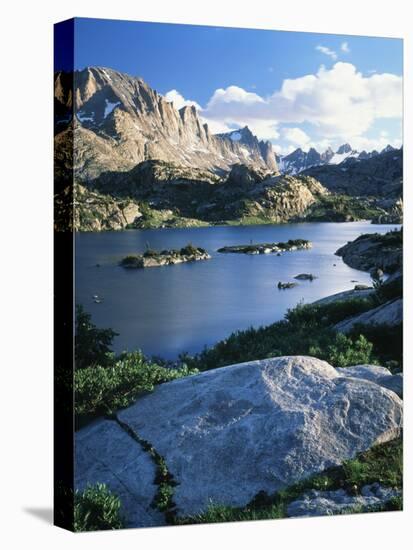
[75,305,118,369]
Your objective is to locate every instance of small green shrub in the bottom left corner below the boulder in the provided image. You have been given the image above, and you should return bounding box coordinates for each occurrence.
[74,483,124,531]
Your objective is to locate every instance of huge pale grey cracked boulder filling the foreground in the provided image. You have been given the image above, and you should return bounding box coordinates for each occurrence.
[76,357,402,522]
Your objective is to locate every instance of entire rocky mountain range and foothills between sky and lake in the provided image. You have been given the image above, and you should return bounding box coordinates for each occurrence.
[55,68,403,231]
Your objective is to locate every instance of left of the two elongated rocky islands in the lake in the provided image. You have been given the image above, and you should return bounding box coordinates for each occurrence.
[120,244,211,269]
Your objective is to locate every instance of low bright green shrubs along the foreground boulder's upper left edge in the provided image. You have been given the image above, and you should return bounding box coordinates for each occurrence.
[74,351,197,417]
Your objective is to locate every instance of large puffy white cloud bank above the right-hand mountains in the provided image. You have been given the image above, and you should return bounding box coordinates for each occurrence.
[202,62,402,147]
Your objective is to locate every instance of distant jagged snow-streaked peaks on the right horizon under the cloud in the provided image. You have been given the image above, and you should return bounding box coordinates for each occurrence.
[276,143,397,175]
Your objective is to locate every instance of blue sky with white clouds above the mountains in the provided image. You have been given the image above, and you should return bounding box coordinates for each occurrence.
[56,18,403,154]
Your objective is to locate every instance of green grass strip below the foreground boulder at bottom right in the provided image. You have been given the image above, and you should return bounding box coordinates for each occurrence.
[175,438,403,525]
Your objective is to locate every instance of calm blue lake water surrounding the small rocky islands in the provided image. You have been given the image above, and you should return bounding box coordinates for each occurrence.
[76,222,395,359]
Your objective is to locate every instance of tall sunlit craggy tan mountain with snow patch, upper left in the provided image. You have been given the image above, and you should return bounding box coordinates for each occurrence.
[55,67,278,182]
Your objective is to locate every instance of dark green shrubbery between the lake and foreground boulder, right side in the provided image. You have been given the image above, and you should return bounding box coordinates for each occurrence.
[181,298,401,370]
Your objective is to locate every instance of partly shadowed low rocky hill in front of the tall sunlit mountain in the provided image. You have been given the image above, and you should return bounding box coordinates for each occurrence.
[86,166,327,231]
